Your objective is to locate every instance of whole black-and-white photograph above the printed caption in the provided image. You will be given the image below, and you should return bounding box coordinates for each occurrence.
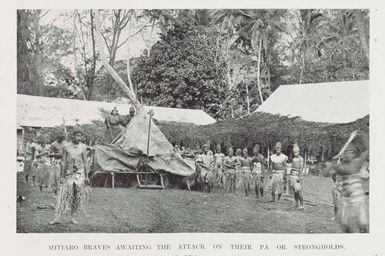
[14,9,371,234]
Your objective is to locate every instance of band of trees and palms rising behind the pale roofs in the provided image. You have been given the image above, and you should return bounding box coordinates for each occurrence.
[17,9,369,120]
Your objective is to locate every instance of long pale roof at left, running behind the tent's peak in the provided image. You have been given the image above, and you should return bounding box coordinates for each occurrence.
[17,94,216,127]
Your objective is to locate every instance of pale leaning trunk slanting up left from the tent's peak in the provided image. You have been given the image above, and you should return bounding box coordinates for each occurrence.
[95,11,141,109]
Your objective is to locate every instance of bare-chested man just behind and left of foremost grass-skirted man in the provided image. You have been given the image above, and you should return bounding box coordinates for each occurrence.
[50,130,68,194]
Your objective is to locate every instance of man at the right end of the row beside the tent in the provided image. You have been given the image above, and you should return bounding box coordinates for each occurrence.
[289,143,304,210]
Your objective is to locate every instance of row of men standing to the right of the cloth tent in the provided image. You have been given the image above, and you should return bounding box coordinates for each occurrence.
[196,142,304,209]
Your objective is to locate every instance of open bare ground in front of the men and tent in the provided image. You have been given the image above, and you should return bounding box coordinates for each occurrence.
[17,174,346,233]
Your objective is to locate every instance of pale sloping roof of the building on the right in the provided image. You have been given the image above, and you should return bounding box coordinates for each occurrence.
[254,81,369,123]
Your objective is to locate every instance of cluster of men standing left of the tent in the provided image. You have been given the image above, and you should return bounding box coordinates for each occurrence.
[24,127,90,224]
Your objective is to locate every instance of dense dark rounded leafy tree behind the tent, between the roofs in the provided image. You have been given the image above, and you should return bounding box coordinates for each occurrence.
[133,21,226,117]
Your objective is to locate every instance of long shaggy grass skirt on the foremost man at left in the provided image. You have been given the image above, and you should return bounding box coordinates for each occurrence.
[56,170,91,217]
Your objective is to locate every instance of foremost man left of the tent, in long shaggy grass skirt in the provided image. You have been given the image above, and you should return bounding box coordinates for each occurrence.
[50,127,90,224]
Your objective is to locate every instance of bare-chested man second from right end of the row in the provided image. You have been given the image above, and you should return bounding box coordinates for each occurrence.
[269,142,288,202]
